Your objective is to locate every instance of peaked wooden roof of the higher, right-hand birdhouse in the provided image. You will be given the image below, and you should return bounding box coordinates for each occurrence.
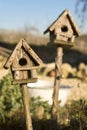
[44,10,80,36]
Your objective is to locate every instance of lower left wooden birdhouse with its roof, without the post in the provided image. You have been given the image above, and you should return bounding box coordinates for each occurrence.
[4,39,42,84]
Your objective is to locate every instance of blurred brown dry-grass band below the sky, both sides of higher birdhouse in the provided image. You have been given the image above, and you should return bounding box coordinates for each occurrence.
[0,30,87,53]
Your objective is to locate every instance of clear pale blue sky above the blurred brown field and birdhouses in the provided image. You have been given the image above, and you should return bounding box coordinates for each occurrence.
[0,0,85,33]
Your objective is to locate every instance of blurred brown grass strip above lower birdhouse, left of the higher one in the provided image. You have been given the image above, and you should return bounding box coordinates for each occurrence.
[0,30,49,45]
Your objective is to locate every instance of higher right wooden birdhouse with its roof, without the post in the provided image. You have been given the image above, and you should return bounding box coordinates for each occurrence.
[44,10,80,46]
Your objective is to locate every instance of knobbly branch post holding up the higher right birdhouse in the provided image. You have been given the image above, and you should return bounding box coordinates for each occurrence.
[52,47,63,122]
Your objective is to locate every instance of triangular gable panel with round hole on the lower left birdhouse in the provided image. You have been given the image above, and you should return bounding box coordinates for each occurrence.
[12,47,36,70]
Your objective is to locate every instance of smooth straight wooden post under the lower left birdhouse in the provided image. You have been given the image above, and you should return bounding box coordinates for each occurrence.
[21,84,33,130]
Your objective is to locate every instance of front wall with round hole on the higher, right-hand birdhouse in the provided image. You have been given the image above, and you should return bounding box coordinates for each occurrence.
[54,15,74,42]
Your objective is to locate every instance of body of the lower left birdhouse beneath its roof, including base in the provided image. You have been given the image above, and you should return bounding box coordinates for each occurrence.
[12,46,37,83]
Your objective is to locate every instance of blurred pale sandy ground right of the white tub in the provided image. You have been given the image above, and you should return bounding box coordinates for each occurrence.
[61,78,87,101]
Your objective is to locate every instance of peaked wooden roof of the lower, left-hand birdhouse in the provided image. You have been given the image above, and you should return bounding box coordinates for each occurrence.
[4,39,43,69]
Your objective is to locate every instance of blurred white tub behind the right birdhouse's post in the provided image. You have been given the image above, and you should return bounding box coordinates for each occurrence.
[27,79,71,106]
